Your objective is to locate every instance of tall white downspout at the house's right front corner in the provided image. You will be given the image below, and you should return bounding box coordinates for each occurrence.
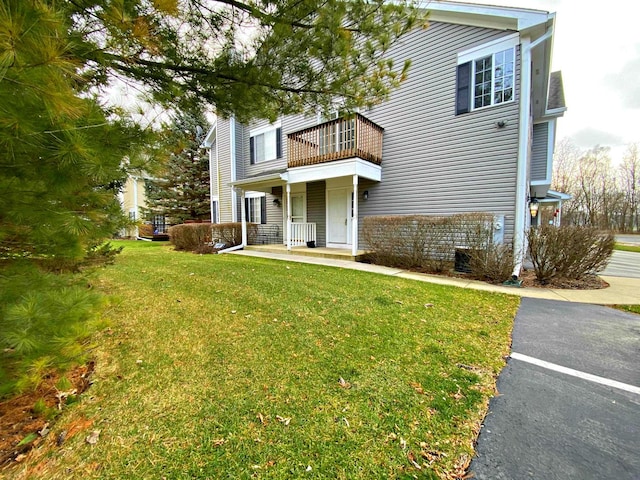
[511,22,553,279]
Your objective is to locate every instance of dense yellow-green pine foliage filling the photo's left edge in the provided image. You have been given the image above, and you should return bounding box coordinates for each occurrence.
[0,0,146,396]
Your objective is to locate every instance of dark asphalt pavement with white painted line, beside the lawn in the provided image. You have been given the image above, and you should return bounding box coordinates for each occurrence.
[470,298,640,480]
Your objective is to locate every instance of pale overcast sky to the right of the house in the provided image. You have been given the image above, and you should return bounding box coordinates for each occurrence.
[466,0,640,163]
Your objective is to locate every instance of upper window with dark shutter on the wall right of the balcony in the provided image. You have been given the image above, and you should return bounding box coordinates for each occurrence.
[456,34,519,115]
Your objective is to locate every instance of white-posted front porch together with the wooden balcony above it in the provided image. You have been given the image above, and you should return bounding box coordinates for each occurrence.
[230,114,384,259]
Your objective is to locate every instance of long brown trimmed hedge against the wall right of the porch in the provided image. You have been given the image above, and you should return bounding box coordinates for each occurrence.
[362,213,513,282]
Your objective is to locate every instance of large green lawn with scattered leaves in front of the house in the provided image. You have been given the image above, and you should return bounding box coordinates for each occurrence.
[12,242,519,479]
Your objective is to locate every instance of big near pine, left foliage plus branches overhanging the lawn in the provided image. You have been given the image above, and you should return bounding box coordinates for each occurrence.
[0,0,420,394]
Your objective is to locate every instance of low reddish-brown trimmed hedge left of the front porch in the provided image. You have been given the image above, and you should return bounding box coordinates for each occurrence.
[169,222,258,253]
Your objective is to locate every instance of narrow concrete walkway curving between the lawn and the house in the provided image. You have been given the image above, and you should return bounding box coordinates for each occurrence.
[233,250,640,305]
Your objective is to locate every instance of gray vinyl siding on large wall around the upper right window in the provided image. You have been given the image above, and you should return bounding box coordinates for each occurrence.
[360,22,520,242]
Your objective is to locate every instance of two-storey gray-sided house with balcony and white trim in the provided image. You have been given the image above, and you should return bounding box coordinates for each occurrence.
[205,2,567,274]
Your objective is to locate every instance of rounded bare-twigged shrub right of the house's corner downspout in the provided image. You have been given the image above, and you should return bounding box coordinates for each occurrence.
[527,225,615,283]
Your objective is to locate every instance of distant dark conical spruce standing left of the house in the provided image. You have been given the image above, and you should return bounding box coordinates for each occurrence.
[142,113,211,225]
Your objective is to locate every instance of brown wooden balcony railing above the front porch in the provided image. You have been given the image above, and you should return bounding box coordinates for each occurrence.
[287,113,384,168]
